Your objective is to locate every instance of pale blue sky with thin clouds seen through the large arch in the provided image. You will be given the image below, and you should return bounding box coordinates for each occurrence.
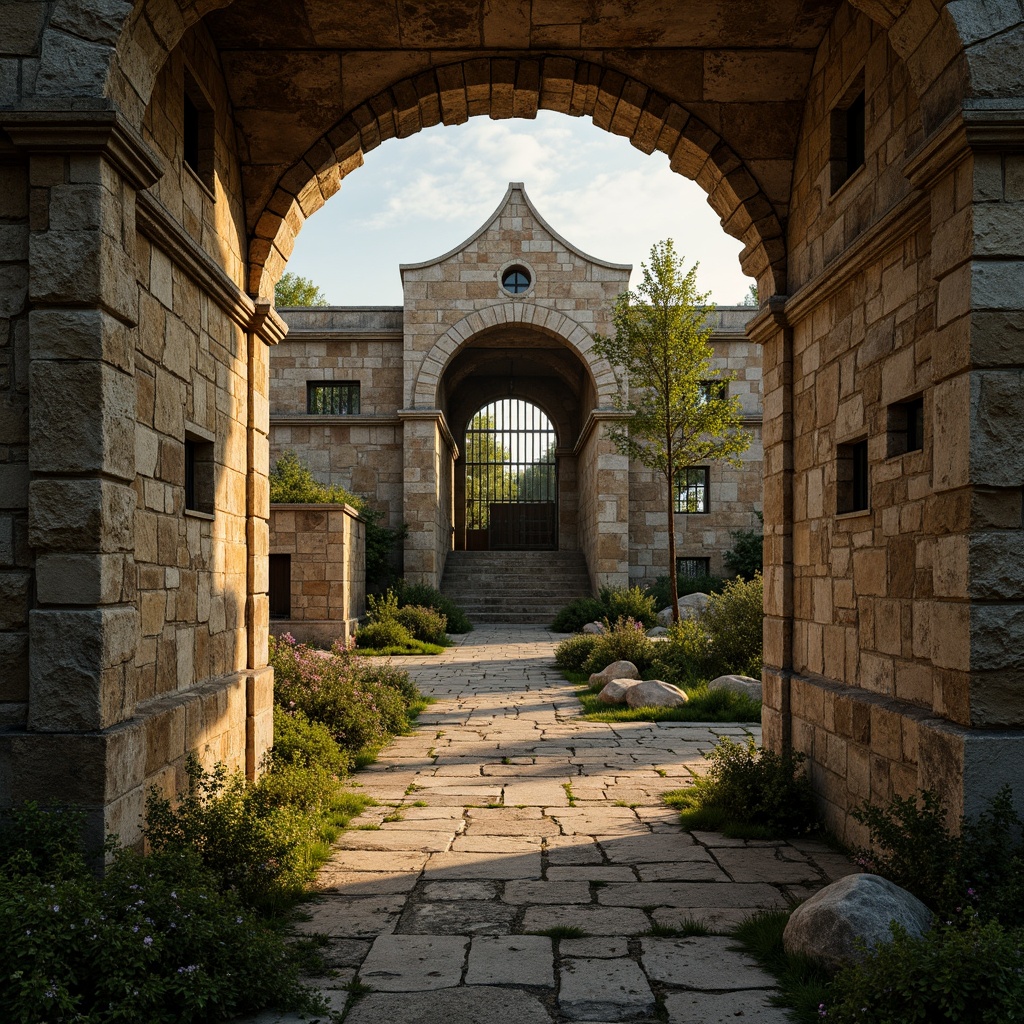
[288,111,751,305]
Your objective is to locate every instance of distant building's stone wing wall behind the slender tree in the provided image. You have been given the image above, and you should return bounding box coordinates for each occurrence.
[630,306,763,586]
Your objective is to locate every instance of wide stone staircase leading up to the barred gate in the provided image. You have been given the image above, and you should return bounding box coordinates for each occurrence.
[441,551,591,626]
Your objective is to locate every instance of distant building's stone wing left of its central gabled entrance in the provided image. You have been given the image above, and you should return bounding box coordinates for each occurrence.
[270,307,402,529]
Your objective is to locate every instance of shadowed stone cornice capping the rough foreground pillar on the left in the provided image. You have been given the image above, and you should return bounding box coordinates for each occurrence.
[0,110,164,189]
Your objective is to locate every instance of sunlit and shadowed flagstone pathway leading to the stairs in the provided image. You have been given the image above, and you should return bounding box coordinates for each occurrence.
[241,626,855,1024]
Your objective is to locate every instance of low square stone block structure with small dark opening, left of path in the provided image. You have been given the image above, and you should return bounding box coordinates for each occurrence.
[270,504,367,646]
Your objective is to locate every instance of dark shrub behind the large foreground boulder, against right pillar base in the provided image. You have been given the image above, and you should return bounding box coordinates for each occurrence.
[851,786,1024,928]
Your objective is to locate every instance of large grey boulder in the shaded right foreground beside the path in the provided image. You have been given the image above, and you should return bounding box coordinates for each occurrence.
[782,872,932,968]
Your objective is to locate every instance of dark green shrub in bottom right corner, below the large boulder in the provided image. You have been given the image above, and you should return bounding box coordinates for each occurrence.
[819,921,1024,1024]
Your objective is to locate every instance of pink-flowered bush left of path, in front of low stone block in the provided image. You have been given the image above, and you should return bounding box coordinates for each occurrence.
[270,634,419,755]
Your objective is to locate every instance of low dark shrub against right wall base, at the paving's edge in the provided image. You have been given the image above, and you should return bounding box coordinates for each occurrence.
[674,737,818,839]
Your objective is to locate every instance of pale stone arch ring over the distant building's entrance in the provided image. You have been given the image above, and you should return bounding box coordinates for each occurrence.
[413,302,621,409]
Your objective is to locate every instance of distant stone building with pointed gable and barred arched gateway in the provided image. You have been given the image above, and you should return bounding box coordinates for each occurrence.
[270,182,762,606]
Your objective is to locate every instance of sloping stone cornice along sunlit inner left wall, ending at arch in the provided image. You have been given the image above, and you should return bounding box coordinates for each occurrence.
[135,191,288,345]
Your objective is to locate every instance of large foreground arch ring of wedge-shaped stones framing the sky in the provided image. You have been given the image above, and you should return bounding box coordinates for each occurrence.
[249,56,786,297]
